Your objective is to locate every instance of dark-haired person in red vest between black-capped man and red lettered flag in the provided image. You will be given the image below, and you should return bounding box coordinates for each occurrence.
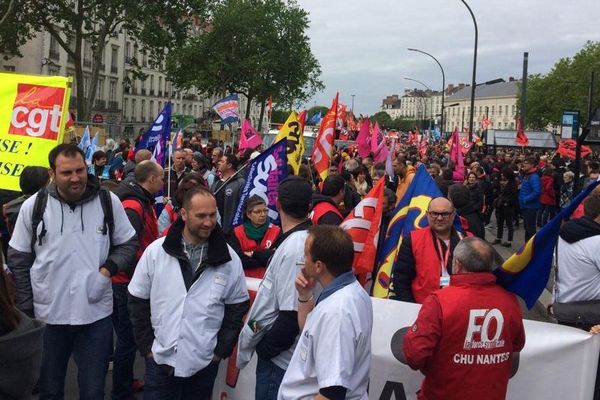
[311,174,346,225]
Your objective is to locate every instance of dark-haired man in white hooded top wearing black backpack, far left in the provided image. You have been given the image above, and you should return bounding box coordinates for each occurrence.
[8,144,137,400]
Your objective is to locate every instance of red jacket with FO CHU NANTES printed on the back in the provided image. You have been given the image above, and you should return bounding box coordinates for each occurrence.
[402,273,525,400]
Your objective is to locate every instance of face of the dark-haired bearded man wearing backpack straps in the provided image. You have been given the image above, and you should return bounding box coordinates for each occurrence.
[50,154,87,201]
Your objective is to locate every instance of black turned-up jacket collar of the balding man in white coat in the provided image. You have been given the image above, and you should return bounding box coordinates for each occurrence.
[162,218,231,267]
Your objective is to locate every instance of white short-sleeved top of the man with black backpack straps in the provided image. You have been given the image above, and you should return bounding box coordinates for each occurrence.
[10,193,135,325]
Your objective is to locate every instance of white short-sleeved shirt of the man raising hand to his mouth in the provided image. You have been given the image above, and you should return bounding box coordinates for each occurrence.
[277,282,373,400]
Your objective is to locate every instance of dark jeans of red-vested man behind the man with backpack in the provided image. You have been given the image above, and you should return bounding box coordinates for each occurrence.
[112,283,136,400]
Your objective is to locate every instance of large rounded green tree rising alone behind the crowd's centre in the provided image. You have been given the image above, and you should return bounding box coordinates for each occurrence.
[167,0,323,129]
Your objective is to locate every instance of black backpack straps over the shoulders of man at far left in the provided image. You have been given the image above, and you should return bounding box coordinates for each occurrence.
[31,187,115,254]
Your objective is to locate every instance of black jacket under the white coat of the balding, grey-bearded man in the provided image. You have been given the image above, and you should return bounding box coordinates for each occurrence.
[128,219,250,358]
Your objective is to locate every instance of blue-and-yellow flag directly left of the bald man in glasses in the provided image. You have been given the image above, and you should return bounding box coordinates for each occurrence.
[373,165,442,298]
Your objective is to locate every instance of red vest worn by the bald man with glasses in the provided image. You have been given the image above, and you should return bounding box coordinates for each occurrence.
[410,227,472,304]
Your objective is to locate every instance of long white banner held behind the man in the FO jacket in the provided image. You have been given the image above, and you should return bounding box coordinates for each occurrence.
[213,298,600,400]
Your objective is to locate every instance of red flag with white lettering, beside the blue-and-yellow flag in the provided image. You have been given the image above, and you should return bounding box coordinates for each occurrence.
[340,179,386,274]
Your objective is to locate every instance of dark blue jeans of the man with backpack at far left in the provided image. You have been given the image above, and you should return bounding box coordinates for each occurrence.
[39,317,113,400]
